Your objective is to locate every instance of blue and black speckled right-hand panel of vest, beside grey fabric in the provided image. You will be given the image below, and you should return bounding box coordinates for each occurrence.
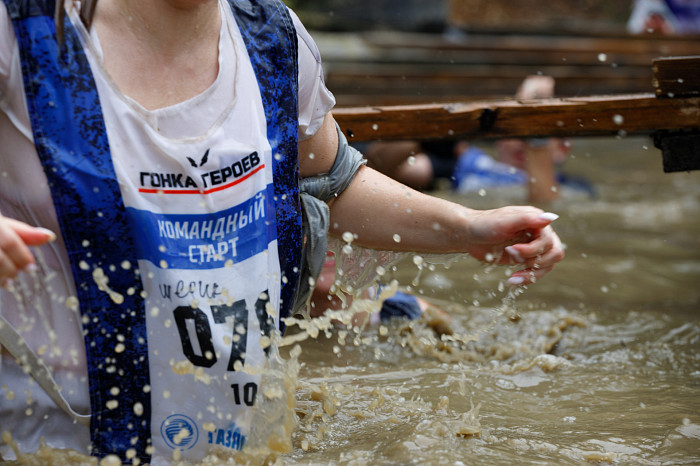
[229,0,303,325]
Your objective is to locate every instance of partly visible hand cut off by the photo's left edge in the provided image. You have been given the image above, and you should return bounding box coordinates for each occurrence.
[0,215,56,286]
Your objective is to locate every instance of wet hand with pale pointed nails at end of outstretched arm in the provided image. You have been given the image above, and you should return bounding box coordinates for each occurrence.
[469,206,564,285]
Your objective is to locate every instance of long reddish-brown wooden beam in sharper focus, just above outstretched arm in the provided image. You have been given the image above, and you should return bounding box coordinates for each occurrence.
[333,94,700,142]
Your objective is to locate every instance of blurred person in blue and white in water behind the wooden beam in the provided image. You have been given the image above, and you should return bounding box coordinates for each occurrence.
[365,75,592,204]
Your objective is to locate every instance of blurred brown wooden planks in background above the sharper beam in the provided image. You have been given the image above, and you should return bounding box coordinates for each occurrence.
[313,32,700,106]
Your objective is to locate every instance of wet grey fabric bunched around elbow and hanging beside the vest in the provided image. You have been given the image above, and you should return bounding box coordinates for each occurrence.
[294,123,367,313]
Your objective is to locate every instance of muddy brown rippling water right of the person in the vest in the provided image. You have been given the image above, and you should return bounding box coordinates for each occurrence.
[283,137,700,465]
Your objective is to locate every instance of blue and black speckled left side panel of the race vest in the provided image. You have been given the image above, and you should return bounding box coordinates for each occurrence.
[5,0,151,462]
